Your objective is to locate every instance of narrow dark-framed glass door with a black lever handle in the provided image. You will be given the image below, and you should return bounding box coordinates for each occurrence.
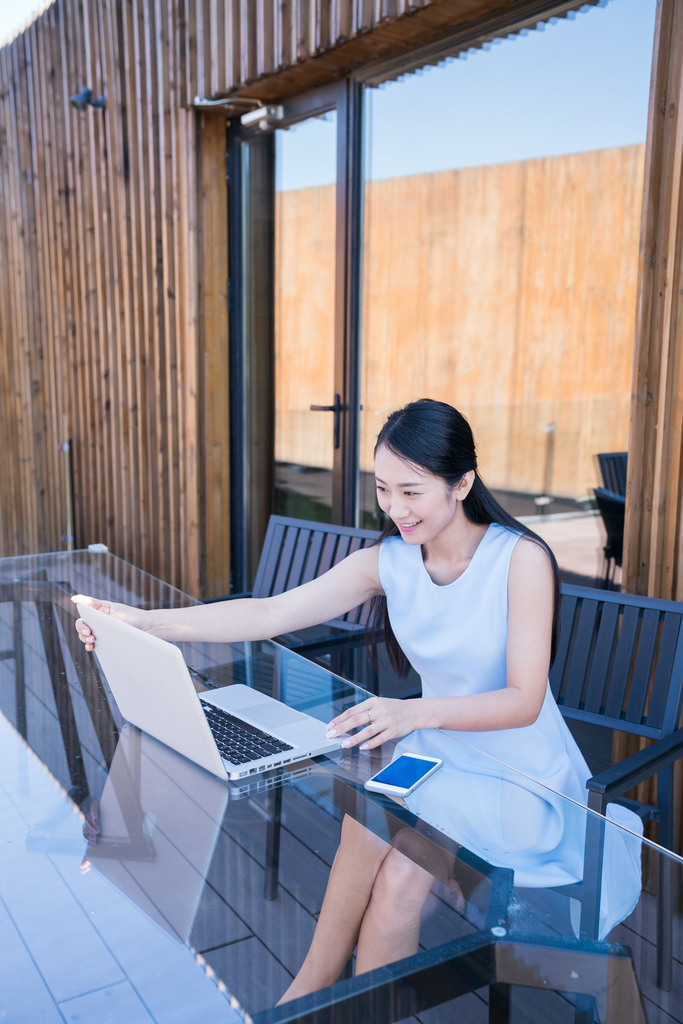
[228,81,360,591]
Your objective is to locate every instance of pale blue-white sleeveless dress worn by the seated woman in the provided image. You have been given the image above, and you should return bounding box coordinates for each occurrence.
[379,523,642,938]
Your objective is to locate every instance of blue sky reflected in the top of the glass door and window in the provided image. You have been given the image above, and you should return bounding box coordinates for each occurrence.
[276,0,655,190]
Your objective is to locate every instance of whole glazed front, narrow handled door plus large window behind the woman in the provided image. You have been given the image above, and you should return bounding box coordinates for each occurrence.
[228,0,655,589]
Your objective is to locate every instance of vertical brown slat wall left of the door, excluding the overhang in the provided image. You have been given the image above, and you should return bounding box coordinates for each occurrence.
[0,0,199,591]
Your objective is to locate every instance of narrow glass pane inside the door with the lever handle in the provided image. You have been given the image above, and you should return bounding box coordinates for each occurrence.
[275,112,337,522]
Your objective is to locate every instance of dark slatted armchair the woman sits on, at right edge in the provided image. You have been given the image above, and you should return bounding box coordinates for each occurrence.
[550,586,683,999]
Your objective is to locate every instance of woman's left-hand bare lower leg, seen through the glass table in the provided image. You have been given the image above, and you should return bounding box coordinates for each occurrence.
[279,815,391,1006]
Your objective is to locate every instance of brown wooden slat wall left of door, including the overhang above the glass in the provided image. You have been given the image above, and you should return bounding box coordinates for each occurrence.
[0,0,448,596]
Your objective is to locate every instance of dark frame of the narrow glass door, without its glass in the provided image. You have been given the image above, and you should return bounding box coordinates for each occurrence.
[227,80,362,593]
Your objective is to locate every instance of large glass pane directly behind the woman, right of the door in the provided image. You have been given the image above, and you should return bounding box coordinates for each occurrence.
[360,0,655,578]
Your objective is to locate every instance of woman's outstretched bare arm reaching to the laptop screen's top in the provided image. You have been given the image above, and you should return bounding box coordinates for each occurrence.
[72,547,382,650]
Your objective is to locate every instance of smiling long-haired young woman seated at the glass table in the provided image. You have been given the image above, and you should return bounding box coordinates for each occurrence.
[74,398,640,1001]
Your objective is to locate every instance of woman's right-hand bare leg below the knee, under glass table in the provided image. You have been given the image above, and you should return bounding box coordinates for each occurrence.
[355,849,434,975]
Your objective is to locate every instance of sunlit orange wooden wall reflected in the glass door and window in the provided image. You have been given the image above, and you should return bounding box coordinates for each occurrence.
[275,145,645,498]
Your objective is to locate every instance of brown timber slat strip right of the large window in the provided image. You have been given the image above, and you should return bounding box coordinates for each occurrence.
[624,0,683,601]
